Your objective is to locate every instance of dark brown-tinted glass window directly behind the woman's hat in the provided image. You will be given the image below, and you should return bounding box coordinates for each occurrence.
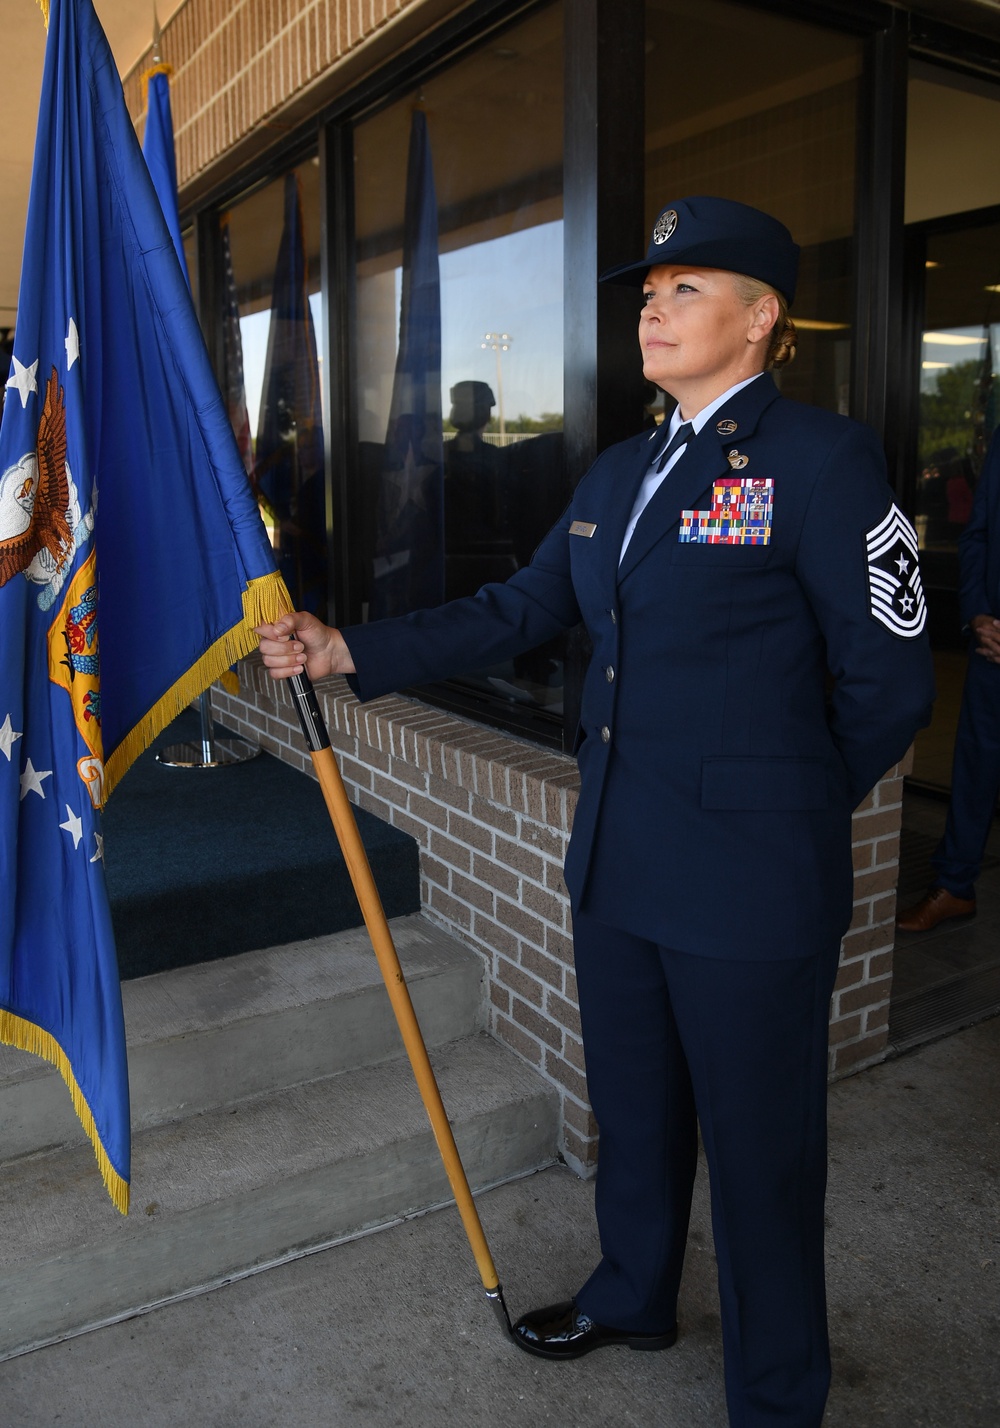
[646,0,861,413]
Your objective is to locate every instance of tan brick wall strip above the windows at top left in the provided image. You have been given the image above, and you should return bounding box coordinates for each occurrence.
[124,0,464,204]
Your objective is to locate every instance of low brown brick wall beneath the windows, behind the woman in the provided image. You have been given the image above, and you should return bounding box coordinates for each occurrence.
[213,660,903,1174]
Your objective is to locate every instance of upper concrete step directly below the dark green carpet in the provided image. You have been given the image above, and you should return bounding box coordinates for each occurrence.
[0,914,484,1162]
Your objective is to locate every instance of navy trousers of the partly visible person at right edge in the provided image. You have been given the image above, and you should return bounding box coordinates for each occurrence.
[931,653,1000,898]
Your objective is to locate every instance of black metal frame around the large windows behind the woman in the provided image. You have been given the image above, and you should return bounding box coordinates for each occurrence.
[181,0,1000,750]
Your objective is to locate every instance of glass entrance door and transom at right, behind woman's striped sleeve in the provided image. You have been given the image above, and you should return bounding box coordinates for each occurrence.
[904,61,1000,791]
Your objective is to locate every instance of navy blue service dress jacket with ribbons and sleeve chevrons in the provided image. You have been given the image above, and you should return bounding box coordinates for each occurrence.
[343,374,933,958]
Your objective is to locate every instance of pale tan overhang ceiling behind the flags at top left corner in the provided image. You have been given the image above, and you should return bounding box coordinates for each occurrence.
[0,0,184,327]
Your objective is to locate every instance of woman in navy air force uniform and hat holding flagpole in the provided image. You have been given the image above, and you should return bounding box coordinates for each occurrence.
[260,197,933,1428]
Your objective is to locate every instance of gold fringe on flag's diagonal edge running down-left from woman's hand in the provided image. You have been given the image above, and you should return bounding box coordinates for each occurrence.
[104,571,291,801]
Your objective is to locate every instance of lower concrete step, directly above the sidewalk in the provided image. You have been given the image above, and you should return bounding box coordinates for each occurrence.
[0,1034,557,1358]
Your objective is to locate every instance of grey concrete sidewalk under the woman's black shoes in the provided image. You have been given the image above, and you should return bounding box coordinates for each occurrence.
[0,1018,1000,1428]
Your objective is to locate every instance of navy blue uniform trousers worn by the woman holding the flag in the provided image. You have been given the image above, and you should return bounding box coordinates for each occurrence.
[573,910,840,1428]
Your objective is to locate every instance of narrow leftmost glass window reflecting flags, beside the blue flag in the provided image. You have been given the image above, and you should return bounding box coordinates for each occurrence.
[220,157,327,615]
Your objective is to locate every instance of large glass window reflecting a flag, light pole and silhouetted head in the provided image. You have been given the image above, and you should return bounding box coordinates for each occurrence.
[353,6,569,727]
